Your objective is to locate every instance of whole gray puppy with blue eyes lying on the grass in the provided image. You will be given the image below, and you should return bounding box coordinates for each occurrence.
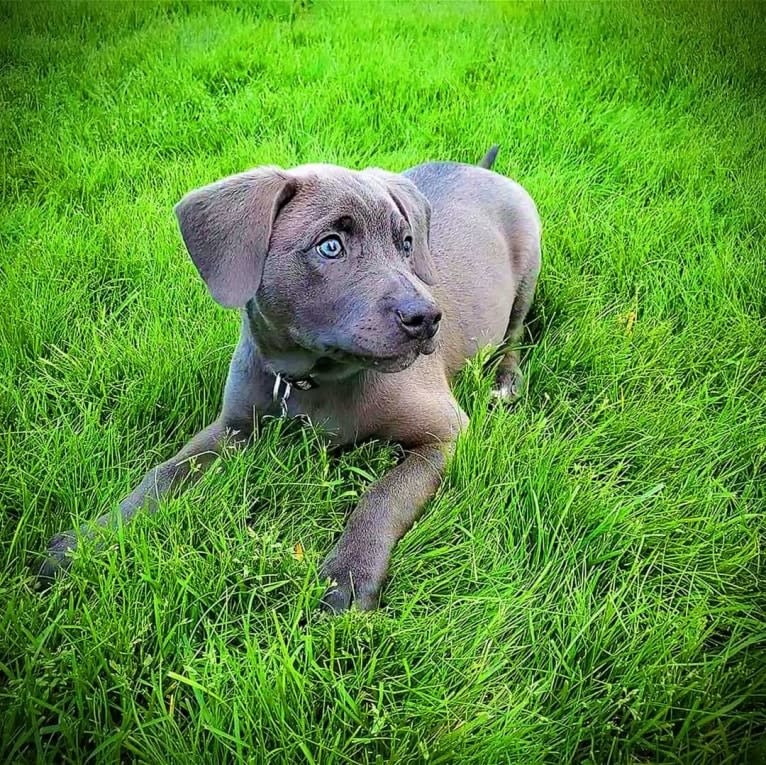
[41,147,540,611]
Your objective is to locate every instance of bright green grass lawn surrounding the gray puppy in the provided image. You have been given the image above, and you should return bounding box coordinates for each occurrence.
[0,2,766,765]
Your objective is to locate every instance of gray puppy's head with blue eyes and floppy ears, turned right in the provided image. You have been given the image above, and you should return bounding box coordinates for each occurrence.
[175,165,441,372]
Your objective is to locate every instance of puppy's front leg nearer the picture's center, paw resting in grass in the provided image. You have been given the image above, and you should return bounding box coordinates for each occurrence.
[320,443,452,613]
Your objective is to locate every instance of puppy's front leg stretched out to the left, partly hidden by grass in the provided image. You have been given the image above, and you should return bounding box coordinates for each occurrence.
[39,420,252,582]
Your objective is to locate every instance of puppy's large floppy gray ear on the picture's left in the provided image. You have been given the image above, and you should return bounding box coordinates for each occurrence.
[174,167,296,308]
